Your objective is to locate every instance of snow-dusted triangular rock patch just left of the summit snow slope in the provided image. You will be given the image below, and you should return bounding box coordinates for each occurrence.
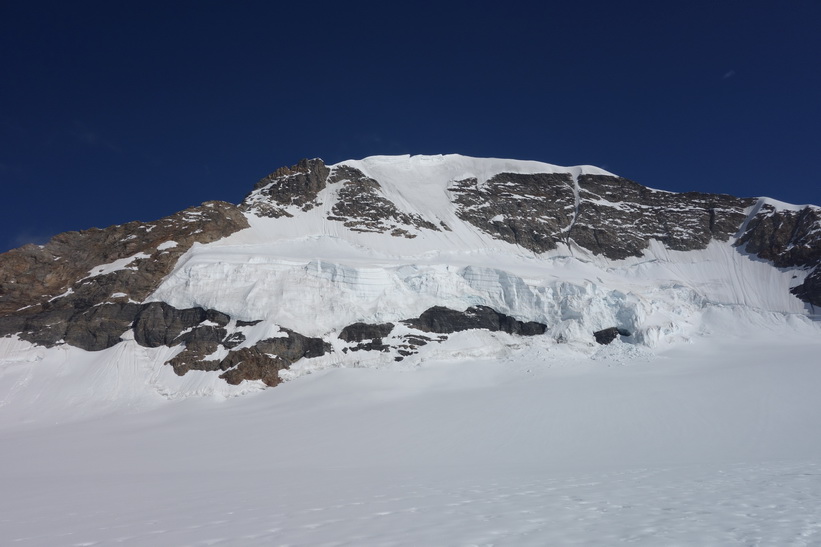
[328,166,439,238]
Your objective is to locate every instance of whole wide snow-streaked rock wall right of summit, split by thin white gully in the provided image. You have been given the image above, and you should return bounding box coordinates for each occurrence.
[450,173,755,259]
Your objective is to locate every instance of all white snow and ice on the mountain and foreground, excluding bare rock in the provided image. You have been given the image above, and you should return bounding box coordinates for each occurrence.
[0,156,821,547]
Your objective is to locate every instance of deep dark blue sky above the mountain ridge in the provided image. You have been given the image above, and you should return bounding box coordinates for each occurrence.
[0,0,821,251]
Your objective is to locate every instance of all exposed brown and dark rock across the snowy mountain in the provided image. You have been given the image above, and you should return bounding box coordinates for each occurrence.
[0,159,821,392]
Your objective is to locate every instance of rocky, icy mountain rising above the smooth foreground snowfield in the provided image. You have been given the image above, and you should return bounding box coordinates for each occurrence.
[0,155,821,396]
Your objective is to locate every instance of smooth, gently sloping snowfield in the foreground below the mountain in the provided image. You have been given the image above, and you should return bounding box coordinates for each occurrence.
[0,309,821,546]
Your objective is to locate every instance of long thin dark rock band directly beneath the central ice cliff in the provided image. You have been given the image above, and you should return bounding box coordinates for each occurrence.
[403,306,547,336]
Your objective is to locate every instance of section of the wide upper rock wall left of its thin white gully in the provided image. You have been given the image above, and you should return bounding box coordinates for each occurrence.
[449,173,576,253]
